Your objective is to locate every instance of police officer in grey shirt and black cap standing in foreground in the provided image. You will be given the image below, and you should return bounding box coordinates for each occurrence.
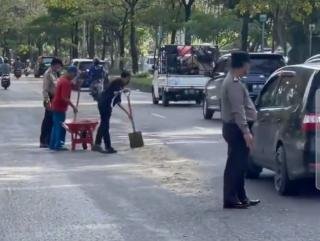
[221,51,260,209]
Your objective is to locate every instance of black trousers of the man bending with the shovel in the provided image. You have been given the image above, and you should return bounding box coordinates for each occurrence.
[95,105,112,149]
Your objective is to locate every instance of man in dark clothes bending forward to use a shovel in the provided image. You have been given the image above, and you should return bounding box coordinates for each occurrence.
[92,71,131,154]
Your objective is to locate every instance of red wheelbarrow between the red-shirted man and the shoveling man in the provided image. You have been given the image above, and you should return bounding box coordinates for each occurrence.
[64,119,99,151]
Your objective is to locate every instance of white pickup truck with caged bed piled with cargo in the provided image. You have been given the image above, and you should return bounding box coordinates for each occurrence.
[152,45,213,106]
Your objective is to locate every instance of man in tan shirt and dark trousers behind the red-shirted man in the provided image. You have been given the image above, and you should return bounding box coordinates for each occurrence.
[40,58,63,148]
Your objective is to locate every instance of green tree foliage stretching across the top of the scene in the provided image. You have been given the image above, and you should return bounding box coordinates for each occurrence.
[0,0,320,65]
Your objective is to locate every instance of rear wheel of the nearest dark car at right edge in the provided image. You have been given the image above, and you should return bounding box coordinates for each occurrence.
[274,146,296,195]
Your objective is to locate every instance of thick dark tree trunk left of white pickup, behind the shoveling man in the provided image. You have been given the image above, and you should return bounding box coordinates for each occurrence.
[130,8,139,73]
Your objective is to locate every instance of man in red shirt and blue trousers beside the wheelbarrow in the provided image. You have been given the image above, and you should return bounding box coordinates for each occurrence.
[50,66,78,151]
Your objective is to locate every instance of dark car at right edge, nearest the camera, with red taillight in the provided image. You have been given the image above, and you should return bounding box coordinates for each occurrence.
[247,64,320,195]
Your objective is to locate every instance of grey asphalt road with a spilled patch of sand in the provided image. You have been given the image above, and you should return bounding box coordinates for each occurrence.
[0,78,320,241]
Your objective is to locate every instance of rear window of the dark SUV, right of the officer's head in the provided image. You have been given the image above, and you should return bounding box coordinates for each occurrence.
[250,56,285,75]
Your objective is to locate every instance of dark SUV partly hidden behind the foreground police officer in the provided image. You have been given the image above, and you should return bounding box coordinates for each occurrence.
[203,53,285,119]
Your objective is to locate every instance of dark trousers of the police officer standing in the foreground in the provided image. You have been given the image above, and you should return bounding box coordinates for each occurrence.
[222,123,252,203]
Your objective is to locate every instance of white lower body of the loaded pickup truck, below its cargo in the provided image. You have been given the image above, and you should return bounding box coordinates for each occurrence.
[152,71,210,106]
